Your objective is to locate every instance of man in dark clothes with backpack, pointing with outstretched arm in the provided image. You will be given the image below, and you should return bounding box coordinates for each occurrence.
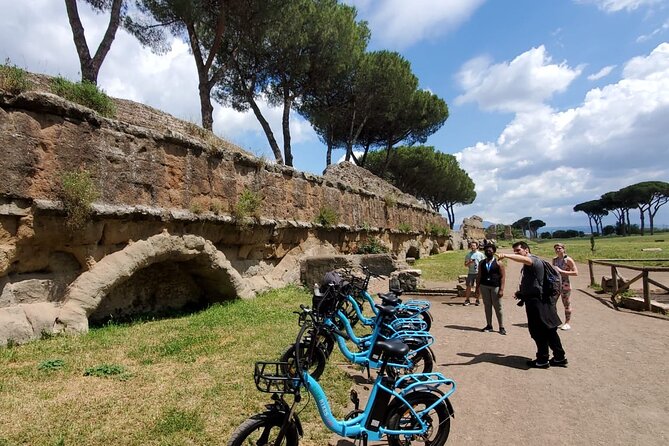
[497,241,568,369]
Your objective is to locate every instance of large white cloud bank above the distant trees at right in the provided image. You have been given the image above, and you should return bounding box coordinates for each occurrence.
[457,43,669,225]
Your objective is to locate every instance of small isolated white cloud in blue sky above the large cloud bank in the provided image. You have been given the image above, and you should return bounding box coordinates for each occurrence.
[455,45,582,112]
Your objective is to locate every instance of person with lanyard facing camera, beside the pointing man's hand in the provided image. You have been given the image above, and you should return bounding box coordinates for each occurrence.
[476,244,506,335]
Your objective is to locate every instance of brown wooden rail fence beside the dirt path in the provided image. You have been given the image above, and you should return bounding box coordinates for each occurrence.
[588,259,669,311]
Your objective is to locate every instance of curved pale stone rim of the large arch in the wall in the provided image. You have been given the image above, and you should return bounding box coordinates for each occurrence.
[54,232,254,332]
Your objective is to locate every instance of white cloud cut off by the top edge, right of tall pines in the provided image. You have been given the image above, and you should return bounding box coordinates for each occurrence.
[346,0,485,49]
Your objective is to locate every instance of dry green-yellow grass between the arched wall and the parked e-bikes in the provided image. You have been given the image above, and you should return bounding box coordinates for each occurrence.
[0,287,353,446]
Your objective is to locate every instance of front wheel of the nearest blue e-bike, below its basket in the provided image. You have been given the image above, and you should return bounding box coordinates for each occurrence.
[228,413,300,446]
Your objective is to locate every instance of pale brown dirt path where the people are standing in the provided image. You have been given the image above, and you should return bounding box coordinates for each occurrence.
[333,256,669,446]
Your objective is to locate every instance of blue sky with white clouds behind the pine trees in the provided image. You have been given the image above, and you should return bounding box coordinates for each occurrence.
[0,0,669,227]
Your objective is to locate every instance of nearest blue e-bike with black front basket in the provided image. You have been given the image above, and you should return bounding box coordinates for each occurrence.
[228,313,455,446]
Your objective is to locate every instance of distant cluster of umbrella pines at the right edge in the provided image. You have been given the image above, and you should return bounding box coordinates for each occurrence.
[574,181,669,235]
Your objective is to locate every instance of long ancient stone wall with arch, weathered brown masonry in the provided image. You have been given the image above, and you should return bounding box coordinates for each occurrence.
[0,82,447,345]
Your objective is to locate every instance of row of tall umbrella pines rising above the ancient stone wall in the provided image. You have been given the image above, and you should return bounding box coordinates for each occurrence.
[64,0,476,229]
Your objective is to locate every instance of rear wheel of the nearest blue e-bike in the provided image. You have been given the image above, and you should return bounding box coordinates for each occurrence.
[386,391,451,446]
